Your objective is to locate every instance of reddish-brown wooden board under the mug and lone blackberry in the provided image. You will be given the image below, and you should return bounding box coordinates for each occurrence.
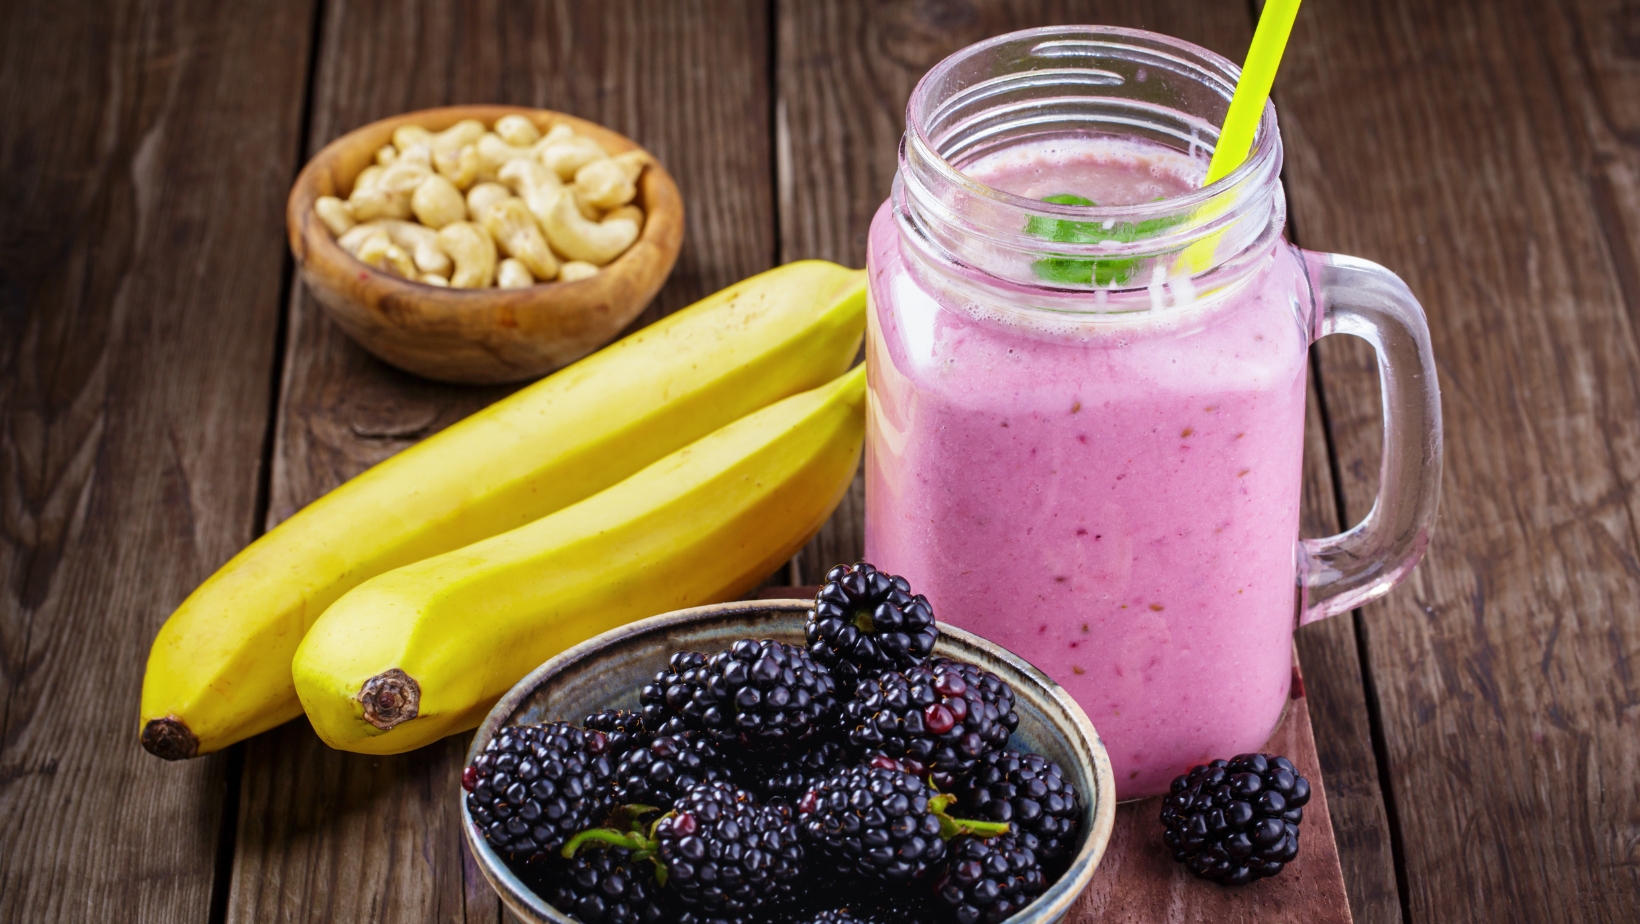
[756,588,1351,924]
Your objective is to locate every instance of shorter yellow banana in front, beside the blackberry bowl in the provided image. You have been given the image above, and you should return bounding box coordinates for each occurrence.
[292,366,866,753]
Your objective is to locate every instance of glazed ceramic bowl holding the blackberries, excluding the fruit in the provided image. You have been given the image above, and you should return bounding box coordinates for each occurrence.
[461,601,1117,924]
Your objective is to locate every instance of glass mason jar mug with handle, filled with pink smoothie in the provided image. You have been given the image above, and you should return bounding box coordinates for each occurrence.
[866,26,1442,798]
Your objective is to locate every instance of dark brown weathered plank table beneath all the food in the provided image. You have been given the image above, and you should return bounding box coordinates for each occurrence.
[0,0,1640,924]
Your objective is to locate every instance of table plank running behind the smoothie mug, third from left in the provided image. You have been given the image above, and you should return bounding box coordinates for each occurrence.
[776,0,1399,922]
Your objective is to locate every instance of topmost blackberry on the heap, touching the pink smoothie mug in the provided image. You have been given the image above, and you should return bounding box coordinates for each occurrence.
[804,561,940,689]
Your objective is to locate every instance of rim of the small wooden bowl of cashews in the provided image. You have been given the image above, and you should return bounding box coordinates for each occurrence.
[285,103,682,302]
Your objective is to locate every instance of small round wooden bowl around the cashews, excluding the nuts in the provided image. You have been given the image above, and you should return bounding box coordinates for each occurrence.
[285,105,684,384]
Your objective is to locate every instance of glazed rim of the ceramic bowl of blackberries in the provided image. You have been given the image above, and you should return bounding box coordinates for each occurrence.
[458,599,1117,924]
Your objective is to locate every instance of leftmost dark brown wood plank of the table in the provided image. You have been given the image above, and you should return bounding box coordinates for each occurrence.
[0,2,310,924]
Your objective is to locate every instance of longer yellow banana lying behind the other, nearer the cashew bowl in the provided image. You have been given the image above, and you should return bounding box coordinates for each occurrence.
[141,261,864,760]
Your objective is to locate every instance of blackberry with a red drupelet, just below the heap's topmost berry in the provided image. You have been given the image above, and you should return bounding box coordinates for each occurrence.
[843,660,1018,789]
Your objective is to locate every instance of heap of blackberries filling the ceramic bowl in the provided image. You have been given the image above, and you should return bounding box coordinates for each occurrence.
[462,563,1102,924]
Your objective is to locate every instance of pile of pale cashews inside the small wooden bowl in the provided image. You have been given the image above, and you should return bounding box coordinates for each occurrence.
[313,115,648,289]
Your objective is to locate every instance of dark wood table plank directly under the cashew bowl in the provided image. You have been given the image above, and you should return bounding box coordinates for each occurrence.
[228,0,774,922]
